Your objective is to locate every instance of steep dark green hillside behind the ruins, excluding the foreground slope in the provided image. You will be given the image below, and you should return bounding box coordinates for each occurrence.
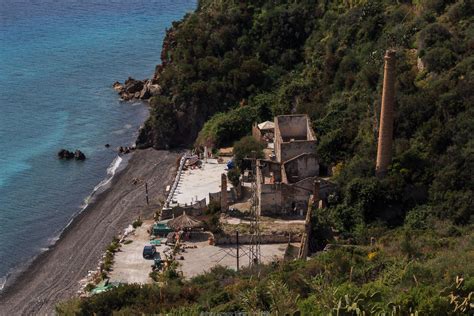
[139,0,474,231]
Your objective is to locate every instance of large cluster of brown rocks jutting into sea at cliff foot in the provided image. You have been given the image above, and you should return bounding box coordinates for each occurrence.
[112,77,161,101]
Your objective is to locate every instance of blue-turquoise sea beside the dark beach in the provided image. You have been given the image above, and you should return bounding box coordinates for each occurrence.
[0,0,197,289]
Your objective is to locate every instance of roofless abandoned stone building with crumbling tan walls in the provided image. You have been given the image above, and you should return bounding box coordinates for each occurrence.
[256,115,319,216]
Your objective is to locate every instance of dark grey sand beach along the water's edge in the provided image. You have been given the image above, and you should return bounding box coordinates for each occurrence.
[0,149,180,315]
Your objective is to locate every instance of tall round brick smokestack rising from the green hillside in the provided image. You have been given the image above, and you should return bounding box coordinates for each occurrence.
[375,50,396,177]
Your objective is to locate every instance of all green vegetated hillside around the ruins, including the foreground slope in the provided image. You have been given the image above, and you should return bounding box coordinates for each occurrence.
[61,0,474,315]
